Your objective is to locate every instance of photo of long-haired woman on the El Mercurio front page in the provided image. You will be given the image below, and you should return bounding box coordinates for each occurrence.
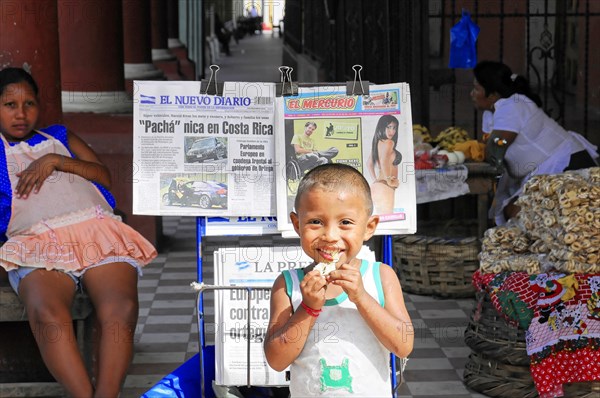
[367,115,402,214]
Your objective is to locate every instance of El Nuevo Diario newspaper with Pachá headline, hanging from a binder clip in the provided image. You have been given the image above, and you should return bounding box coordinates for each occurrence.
[133,81,275,216]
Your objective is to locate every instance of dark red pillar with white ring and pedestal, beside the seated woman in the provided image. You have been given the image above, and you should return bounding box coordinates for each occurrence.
[55,0,161,244]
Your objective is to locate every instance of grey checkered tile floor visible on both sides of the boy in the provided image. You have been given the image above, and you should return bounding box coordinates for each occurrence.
[121,217,483,398]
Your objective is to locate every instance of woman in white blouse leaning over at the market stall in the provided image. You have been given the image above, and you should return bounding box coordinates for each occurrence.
[471,61,598,225]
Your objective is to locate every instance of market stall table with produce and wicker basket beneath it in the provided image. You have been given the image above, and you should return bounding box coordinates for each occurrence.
[393,125,497,298]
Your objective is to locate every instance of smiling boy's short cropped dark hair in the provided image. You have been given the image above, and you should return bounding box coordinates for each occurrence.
[294,163,373,216]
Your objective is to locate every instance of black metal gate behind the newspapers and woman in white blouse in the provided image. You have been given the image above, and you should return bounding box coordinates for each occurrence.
[285,0,600,144]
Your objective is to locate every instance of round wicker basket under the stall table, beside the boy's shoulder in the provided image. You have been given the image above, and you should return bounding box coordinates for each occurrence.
[394,236,480,298]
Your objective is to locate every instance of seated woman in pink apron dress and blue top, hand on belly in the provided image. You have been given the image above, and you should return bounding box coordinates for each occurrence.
[0,68,156,398]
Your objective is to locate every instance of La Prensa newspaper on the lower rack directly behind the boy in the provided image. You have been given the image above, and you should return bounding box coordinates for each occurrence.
[214,245,375,386]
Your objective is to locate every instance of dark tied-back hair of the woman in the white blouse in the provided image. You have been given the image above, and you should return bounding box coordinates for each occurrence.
[473,61,542,107]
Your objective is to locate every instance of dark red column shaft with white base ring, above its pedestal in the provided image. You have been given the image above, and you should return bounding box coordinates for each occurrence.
[57,0,132,113]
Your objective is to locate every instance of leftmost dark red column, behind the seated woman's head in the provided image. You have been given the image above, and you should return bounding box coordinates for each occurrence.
[0,0,62,126]
